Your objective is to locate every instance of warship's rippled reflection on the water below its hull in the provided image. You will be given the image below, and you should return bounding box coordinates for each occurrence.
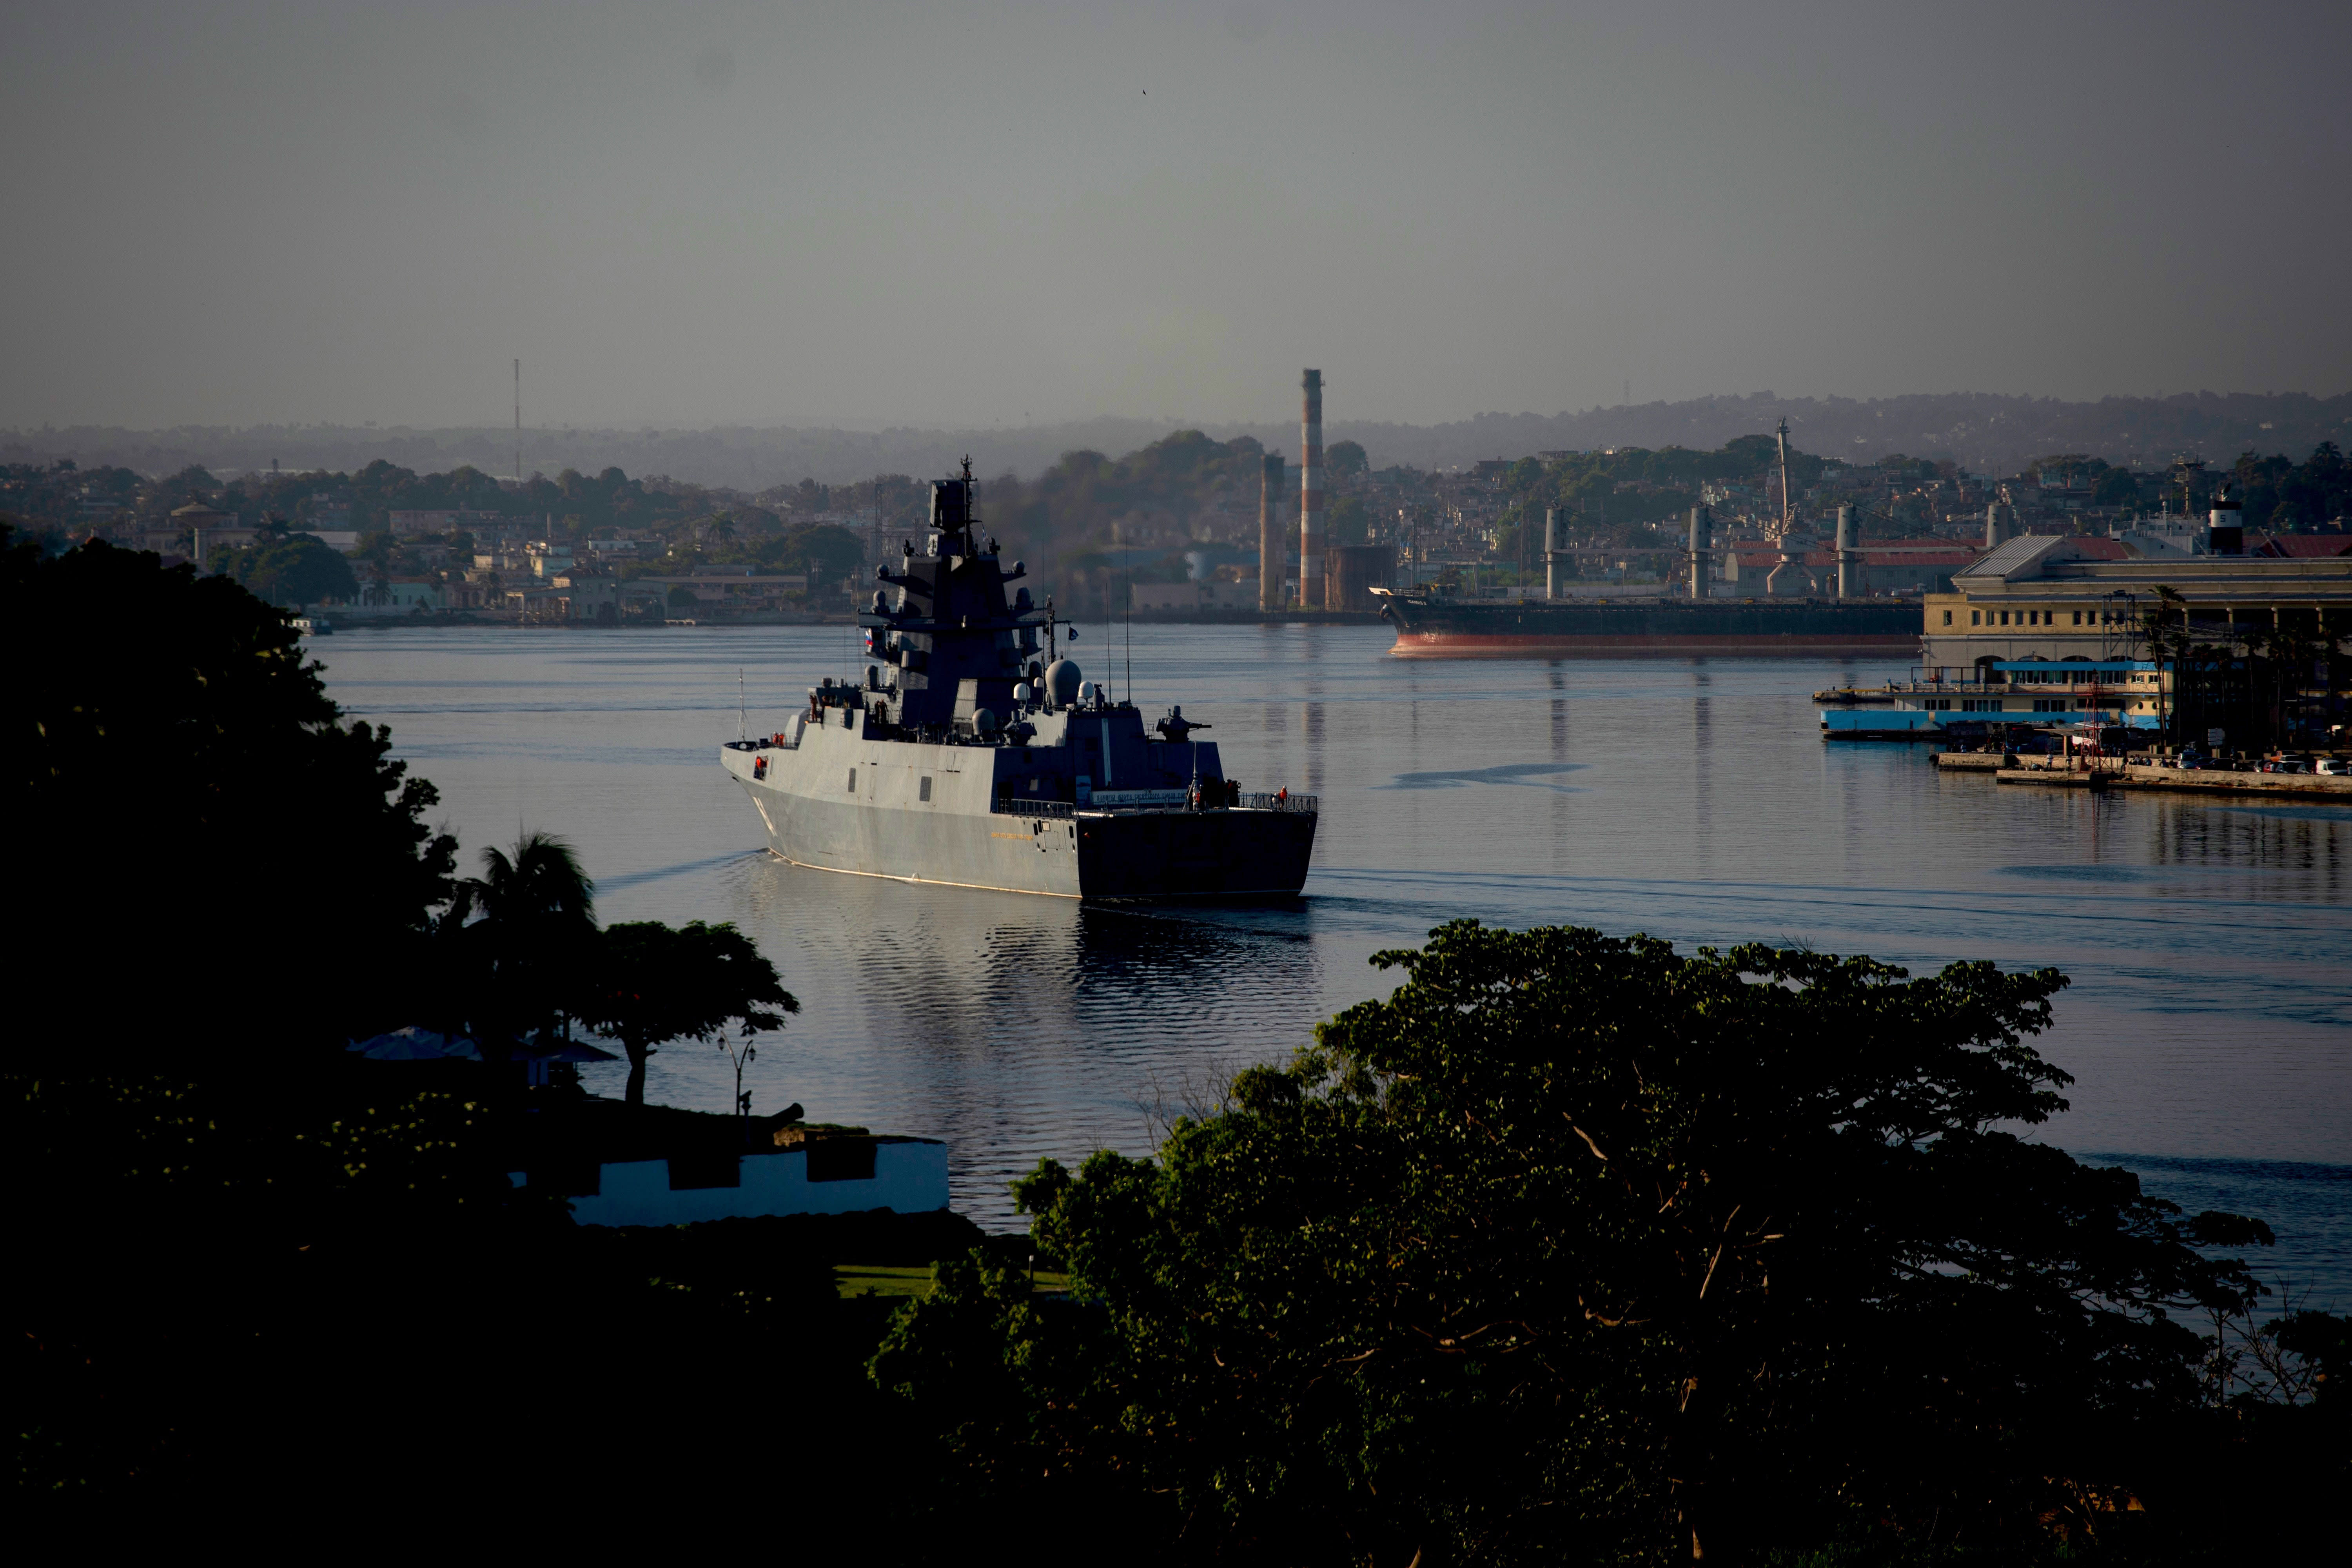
[736,856,1324,1222]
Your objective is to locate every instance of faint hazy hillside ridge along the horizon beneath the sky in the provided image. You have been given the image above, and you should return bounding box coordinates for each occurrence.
[14,392,2352,491]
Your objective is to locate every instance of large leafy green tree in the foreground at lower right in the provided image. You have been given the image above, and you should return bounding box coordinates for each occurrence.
[875,922,2267,1561]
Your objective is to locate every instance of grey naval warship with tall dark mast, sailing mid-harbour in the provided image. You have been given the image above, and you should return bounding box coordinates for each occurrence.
[720,458,1319,900]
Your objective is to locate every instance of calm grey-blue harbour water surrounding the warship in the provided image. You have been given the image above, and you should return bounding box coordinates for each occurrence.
[315,625,2352,1307]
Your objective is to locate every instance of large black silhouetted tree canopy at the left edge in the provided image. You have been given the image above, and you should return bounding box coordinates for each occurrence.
[0,536,456,1065]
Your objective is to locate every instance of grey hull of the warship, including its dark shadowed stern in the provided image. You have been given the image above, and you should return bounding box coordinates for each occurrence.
[720,717,1317,898]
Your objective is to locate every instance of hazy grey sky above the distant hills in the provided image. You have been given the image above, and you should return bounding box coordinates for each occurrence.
[0,0,2352,425]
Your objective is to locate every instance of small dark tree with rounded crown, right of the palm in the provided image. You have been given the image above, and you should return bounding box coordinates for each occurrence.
[574,919,800,1105]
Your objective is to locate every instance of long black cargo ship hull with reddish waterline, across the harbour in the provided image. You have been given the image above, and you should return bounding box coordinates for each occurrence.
[1381,595,1924,658]
